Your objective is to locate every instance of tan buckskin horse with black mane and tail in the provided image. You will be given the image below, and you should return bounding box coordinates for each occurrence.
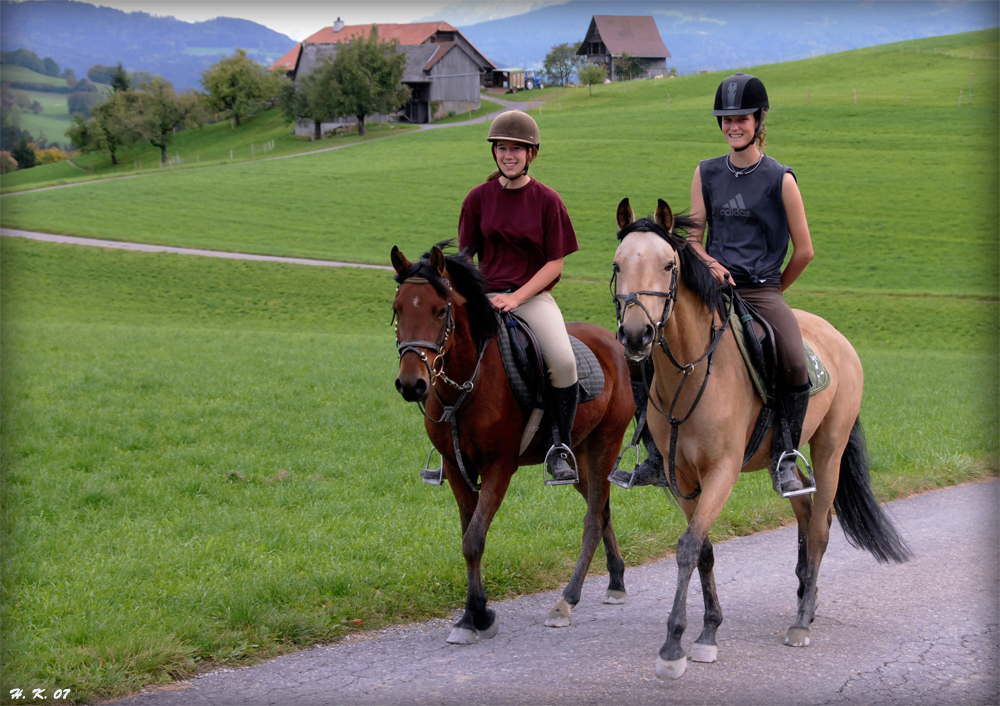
[611,198,912,679]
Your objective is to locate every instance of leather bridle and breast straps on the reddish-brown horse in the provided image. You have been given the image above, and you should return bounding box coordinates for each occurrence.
[393,277,492,492]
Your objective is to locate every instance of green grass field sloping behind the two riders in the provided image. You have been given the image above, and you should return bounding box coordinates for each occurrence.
[0,30,1000,701]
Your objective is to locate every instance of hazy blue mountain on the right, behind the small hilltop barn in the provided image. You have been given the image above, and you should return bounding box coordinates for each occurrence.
[458,0,1000,74]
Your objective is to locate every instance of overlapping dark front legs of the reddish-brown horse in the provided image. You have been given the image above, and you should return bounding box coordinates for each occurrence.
[446,462,512,645]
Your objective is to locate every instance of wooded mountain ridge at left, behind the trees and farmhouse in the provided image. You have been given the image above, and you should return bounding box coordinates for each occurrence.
[0,0,295,89]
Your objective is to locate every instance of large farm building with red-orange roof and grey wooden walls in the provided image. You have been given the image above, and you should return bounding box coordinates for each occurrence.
[272,18,496,136]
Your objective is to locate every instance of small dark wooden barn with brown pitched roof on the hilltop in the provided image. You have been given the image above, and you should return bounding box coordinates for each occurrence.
[576,15,670,81]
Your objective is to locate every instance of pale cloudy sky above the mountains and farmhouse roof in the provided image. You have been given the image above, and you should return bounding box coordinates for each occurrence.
[91,0,567,41]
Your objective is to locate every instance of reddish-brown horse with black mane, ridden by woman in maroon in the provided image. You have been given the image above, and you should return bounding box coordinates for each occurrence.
[391,243,635,645]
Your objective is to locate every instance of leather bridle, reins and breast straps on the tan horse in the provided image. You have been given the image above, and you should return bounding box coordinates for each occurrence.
[610,236,733,500]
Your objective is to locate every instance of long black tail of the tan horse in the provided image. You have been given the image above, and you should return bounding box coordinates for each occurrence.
[833,417,913,564]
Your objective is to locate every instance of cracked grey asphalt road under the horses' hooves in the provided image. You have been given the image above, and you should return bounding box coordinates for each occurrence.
[109,480,1000,706]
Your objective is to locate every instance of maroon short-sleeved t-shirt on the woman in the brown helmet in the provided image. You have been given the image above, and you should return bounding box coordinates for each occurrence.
[458,179,580,292]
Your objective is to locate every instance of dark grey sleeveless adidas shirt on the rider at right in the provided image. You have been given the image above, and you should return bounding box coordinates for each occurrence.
[699,155,795,287]
